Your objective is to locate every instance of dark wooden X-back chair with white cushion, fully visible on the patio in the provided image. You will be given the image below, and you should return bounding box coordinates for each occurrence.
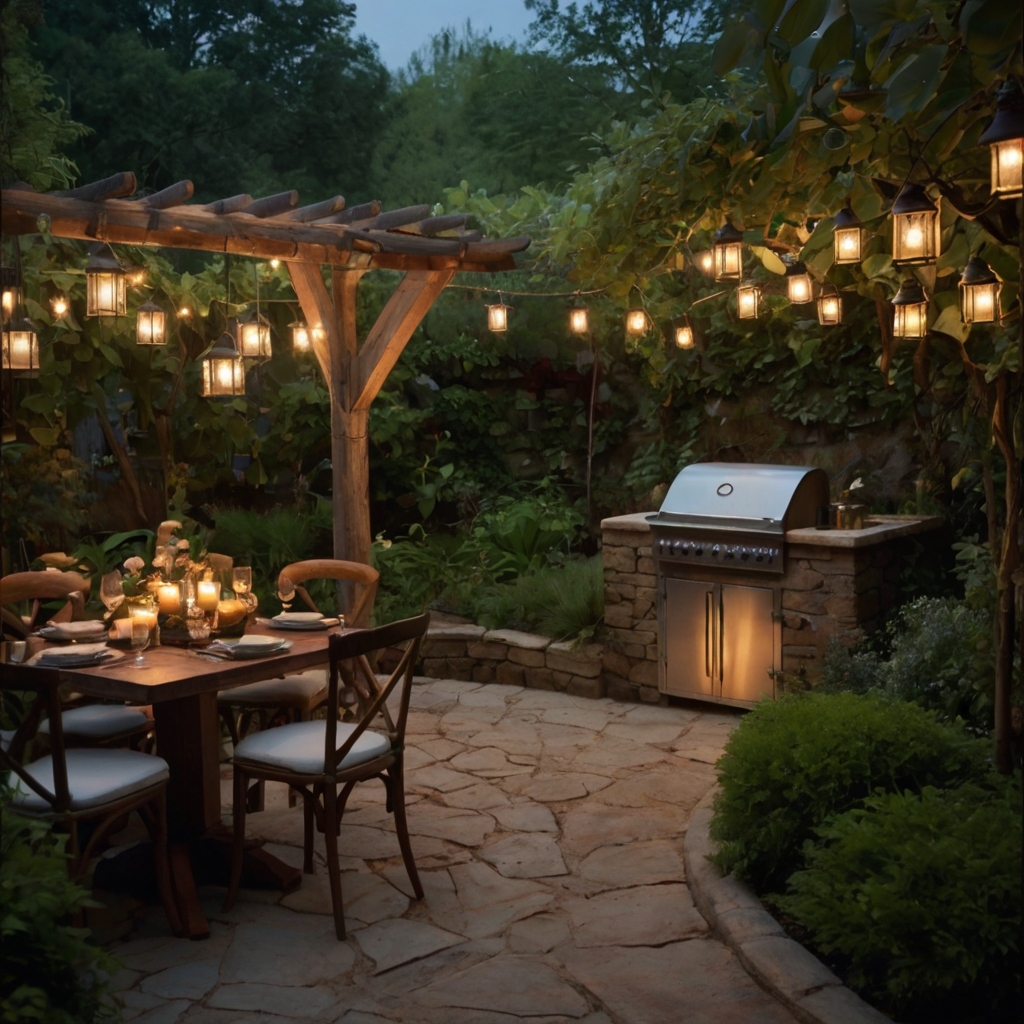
[224,612,430,939]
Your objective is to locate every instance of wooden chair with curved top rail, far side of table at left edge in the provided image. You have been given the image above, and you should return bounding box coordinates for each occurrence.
[0,569,153,746]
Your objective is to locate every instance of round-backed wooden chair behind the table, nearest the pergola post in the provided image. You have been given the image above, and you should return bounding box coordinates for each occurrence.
[217,558,380,744]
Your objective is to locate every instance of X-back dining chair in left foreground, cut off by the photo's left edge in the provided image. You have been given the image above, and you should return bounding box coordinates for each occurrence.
[0,670,181,934]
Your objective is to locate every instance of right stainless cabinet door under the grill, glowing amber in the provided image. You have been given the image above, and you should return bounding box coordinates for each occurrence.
[716,584,775,700]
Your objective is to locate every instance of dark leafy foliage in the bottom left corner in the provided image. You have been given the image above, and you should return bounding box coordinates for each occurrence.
[0,806,120,1024]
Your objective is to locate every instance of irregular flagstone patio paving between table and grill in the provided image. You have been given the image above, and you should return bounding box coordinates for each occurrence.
[113,679,794,1024]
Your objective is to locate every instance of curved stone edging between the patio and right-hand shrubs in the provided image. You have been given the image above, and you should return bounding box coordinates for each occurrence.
[683,786,892,1024]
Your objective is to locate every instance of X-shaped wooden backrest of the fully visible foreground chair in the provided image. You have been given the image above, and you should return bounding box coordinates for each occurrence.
[324,611,430,776]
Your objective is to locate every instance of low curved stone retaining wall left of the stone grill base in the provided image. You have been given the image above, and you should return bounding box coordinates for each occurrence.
[420,624,605,697]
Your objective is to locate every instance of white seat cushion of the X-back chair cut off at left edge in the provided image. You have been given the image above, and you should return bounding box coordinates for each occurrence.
[10,749,168,811]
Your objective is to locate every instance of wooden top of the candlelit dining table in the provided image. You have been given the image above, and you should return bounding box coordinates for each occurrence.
[3,625,355,703]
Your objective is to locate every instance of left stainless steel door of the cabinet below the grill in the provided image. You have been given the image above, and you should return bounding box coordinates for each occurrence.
[662,579,715,696]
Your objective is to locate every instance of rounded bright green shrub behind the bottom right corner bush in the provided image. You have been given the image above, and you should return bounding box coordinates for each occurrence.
[711,693,989,892]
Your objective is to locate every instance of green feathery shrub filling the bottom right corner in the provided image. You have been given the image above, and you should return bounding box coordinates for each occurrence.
[771,780,1021,1024]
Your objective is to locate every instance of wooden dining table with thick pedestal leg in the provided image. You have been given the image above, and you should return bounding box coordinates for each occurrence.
[3,624,350,938]
